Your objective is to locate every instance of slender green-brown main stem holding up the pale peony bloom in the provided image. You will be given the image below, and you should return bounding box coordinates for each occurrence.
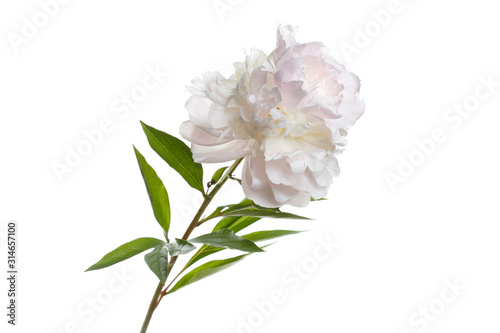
[141,158,243,333]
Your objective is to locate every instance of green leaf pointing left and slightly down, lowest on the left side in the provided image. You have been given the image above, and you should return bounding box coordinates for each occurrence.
[86,237,165,272]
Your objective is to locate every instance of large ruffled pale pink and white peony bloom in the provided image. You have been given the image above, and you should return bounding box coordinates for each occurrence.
[180,25,364,207]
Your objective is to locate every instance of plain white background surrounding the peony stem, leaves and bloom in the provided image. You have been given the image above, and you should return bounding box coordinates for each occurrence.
[0,0,500,333]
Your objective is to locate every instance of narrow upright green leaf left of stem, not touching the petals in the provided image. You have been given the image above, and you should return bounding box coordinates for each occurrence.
[134,147,170,235]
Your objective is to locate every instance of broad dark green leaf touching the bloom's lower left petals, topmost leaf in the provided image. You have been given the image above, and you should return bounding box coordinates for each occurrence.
[141,121,204,193]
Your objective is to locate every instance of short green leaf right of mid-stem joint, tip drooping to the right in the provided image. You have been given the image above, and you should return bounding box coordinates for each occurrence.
[189,229,264,252]
